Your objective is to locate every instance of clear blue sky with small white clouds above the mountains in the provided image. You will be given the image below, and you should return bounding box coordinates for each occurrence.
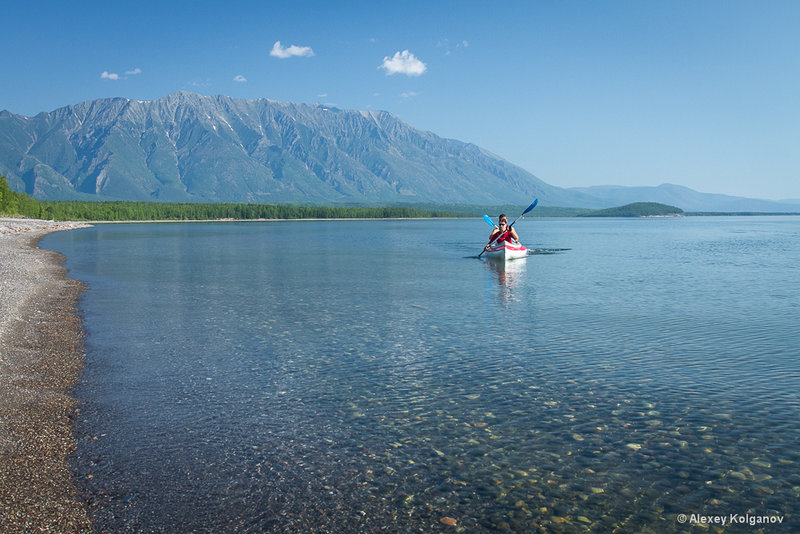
[0,0,800,200]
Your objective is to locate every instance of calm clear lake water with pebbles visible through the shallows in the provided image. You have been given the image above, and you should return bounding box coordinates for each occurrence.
[42,217,800,533]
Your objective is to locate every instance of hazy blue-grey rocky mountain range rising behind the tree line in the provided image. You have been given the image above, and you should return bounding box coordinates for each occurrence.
[0,92,800,211]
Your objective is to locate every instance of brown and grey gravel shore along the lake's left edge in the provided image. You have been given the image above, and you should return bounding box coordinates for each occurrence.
[0,218,91,534]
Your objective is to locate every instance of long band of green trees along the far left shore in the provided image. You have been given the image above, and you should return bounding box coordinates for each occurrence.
[0,175,472,221]
